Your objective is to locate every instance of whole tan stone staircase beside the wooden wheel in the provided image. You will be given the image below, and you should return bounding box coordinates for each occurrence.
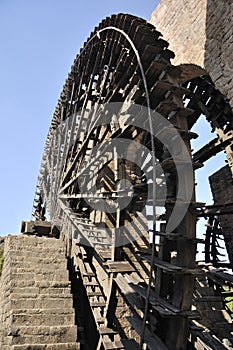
[0,235,80,350]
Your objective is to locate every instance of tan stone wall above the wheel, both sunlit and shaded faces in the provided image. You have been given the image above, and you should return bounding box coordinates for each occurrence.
[149,0,233,107]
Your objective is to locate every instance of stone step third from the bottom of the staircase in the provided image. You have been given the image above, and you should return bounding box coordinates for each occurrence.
[5,308,75,328]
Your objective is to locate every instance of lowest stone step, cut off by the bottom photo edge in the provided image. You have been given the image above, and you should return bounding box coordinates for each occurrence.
[11,343,80,350]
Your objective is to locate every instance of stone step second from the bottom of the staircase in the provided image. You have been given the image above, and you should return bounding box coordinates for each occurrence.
[5,325,77,349]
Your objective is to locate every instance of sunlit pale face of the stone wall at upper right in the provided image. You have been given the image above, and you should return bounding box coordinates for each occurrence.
[149,0,206,67]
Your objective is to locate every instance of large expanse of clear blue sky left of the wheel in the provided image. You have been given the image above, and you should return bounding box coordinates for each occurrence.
[0,0,159,235]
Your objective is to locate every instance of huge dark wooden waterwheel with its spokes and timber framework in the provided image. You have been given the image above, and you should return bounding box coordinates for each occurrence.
[31,14,233,350]
